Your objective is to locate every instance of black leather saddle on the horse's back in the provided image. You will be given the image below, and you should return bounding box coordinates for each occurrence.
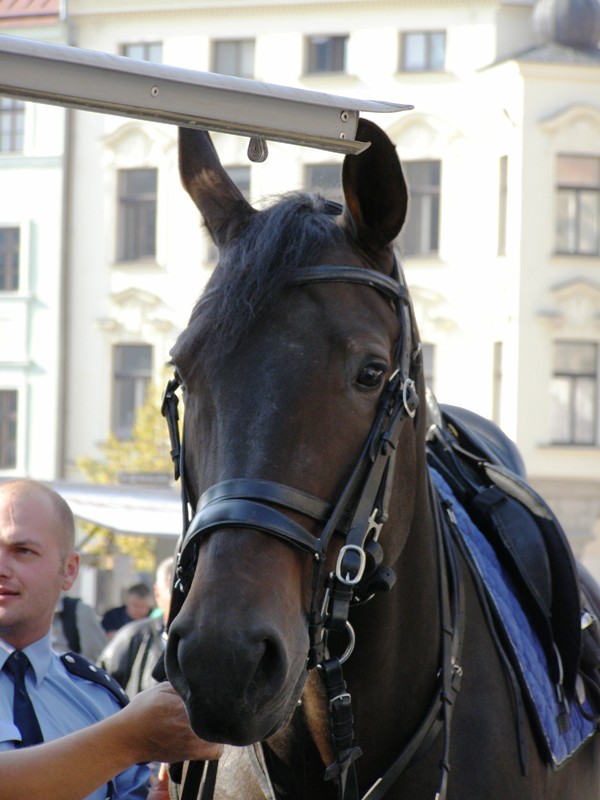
[427,395,598,698]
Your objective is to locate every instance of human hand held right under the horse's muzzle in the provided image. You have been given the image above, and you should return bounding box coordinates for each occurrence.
[119,683,223,762]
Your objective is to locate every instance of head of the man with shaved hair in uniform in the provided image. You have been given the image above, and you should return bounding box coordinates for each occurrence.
[0,480,79,649]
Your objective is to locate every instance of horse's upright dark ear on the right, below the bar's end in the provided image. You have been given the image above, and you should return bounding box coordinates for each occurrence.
[342,119,408,249]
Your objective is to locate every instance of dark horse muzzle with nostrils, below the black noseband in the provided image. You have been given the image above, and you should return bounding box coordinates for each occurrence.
[165,531,308,746]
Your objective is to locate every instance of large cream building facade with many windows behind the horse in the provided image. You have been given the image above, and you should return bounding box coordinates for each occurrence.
[0,0,600,577]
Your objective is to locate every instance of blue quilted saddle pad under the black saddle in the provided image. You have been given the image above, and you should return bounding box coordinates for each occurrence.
[430,468,596,767]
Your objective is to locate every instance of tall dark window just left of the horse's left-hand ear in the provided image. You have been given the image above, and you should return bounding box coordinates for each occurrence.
[117,169,157,261]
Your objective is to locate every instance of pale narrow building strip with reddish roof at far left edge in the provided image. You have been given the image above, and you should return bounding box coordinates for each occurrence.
[0,0,67,477]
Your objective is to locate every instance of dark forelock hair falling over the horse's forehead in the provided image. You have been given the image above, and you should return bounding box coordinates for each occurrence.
[178,192,347,363]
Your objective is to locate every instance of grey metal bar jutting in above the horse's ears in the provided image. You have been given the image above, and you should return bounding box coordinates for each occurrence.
[0,35,412,153]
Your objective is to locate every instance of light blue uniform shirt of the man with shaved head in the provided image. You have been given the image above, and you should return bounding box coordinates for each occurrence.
[0,633,150,800]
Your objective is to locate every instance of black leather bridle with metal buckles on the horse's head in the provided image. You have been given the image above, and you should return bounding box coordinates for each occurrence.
[162,259,460,800]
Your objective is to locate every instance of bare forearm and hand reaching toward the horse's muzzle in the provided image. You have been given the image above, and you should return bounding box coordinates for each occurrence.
[0,683,222,800]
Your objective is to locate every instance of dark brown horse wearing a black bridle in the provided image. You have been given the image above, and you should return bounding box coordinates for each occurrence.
[165,119,600,800]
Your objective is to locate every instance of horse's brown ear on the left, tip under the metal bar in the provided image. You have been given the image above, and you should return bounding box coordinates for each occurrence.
[179,128,255,248]
